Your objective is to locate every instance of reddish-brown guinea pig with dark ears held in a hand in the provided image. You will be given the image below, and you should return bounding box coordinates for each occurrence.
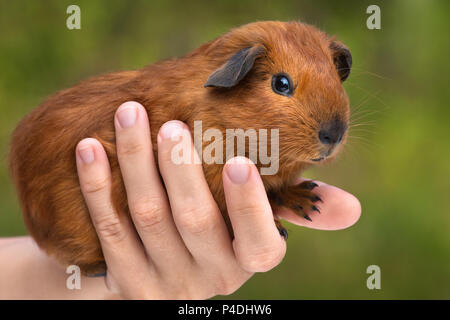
[9,21,352,274]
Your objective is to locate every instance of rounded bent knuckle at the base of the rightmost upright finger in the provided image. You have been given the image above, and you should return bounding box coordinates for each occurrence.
[239,246,285,272]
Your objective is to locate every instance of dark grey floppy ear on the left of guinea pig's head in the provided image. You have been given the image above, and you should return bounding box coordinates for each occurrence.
[205,46,264,88]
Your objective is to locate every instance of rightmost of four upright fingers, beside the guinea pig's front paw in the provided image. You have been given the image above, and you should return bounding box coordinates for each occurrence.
[223,157,286,272]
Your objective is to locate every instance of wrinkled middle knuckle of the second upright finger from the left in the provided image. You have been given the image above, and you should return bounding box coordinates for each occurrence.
[131,198,168,230]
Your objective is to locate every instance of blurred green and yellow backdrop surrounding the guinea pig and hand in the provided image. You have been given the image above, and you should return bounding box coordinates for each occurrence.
[0,0,450,299]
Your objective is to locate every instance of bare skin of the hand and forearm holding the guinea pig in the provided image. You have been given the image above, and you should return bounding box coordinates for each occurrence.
[0,102,361,299]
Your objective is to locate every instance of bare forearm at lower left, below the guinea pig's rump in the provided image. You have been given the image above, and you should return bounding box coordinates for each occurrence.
[0,237,118,299]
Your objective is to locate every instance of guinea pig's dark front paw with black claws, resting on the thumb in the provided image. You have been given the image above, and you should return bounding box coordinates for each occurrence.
[268,180,323,222]
